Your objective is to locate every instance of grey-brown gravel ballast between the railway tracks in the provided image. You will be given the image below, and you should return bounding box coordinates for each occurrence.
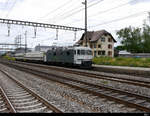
[0,65,147,113]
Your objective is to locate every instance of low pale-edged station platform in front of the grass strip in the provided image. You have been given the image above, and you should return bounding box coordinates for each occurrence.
[92,64,150,78]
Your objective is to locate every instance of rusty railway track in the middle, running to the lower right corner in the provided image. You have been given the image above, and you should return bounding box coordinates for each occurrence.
[0,60,150,112]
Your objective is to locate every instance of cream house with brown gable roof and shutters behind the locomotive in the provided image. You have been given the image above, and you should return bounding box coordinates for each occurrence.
[76,30,116,57]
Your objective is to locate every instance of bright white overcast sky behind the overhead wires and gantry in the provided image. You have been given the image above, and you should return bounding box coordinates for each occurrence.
[0,0,150,47]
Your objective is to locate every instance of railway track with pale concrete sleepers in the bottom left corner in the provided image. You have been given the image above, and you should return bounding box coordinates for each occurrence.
[1,70,62,113]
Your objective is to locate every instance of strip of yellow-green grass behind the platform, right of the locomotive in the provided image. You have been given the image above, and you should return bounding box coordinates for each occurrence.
[93,57,150,68]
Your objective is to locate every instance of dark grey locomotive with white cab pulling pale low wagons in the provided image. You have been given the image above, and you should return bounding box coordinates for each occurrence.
[13,47,93,68]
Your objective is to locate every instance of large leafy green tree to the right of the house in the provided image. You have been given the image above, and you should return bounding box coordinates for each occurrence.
[117,24,150,53]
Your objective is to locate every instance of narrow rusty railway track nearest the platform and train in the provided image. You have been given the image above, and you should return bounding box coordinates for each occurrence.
[8,62,150,88]
